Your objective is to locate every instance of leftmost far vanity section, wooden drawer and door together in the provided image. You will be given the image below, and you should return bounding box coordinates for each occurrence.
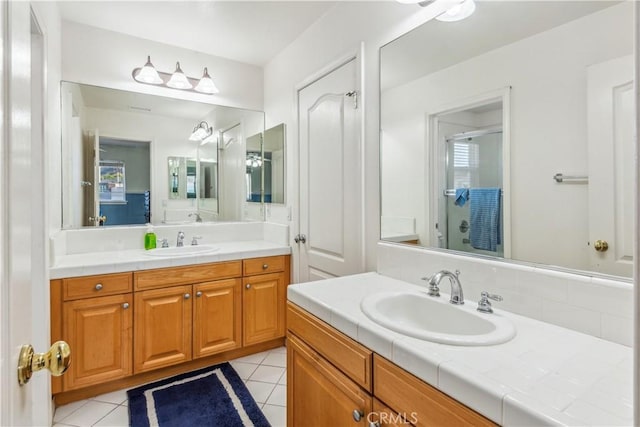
[54,274,133,390]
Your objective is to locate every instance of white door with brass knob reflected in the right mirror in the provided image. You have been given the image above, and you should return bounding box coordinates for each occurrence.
[587,56,636,277]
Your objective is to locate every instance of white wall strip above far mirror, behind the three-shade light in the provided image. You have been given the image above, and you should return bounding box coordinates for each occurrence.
[62,21,263,110]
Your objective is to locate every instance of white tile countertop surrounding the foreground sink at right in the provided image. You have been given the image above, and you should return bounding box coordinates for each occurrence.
[288,273,633,426]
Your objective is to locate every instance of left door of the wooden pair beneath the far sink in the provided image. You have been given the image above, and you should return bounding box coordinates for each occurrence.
[133,285,193,374]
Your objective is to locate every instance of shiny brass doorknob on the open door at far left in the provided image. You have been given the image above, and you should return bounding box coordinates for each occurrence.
[18,341,71,385]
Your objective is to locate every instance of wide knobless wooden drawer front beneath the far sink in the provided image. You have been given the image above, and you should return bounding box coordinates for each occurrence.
[133,261,242,291]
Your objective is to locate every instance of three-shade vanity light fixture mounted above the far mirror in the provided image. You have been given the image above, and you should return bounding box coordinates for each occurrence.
[131,56,219,95]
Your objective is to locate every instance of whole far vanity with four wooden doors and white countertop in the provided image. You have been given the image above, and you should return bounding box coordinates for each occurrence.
[51,227,290,404]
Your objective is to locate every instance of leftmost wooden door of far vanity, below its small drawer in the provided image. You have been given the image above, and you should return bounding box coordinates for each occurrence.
[62,294,133,391]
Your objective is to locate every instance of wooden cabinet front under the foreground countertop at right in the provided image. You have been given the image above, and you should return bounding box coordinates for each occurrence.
[287,303,496,427]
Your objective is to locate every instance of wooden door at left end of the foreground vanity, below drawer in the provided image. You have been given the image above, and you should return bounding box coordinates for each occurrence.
[287,335,375,427]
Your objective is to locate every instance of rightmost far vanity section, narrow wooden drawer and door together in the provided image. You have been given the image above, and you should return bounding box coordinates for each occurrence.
[242,256,289,345]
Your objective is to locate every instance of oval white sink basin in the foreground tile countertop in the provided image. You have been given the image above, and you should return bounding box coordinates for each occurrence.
[360,292,516,346]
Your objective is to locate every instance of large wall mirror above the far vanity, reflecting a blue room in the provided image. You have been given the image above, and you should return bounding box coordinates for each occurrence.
[61,82,264,229]
